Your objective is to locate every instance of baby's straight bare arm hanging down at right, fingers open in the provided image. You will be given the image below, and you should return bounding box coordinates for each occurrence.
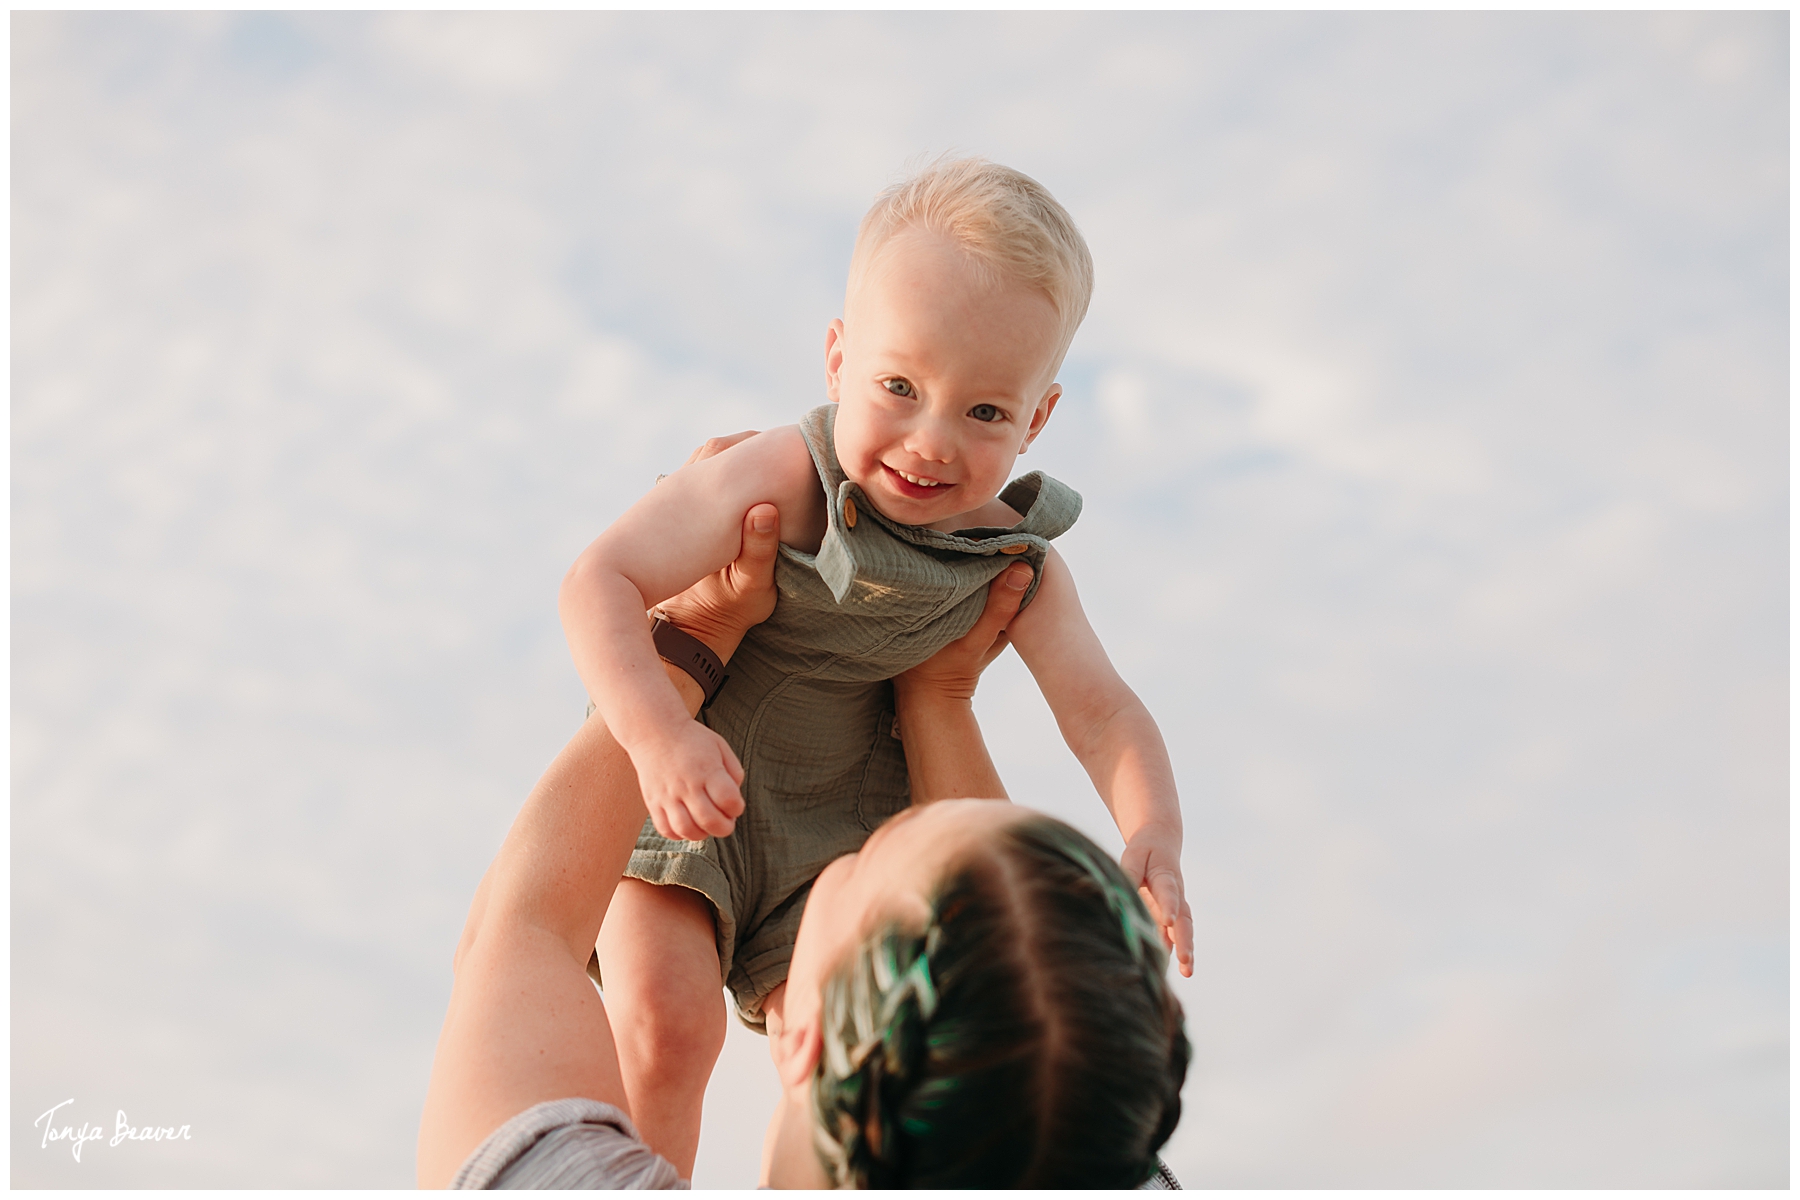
[1008,551,1193,975]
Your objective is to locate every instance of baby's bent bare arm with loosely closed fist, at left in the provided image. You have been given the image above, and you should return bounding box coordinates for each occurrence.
[558,426,823,835]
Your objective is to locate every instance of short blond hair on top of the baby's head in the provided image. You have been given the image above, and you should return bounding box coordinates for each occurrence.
[848,157,1094,376]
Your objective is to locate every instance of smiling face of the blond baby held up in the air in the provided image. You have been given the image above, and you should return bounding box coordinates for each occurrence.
[824,230,1062,525]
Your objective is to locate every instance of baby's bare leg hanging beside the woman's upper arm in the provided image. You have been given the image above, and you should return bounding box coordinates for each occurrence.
[598,880,725,1178]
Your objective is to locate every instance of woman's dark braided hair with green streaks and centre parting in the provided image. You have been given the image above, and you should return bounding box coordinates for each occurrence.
[814,815,1188,1187]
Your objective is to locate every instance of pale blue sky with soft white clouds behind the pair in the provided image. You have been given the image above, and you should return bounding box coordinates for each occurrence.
[13,13,1787,1187]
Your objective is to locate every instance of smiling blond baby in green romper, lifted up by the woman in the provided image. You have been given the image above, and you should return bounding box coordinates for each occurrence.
[560,158,1192,1175]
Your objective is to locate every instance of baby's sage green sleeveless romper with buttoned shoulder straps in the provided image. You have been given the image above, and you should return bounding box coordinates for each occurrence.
[626,405,1082,1031]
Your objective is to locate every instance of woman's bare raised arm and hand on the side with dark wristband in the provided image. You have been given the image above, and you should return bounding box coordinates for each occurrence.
[418,506,778,1187]
